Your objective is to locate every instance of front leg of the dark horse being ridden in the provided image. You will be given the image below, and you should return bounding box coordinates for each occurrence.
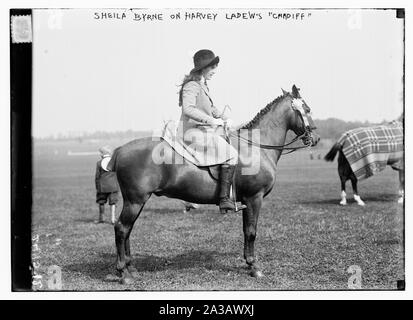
[242,194,263,278]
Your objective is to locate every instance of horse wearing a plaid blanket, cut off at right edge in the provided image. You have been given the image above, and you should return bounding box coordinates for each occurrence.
[324,121,404,206]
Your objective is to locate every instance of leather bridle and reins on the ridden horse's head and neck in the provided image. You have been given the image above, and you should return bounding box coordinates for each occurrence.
[229,98,313,154]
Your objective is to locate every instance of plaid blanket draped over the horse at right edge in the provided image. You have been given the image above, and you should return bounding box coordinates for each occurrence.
[338,121,404,180]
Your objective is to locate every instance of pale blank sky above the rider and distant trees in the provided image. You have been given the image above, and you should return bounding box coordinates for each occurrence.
[33,9,403,137]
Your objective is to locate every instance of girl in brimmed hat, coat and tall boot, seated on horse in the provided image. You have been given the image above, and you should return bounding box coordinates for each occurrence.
[178,50,238,213]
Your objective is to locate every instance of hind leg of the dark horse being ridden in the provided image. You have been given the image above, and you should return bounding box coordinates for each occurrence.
[115,201,145,284]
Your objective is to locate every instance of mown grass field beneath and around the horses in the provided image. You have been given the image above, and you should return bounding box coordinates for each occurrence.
[33,140,404,290]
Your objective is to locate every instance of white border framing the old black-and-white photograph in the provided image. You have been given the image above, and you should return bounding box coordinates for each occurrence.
[0,0,413,300]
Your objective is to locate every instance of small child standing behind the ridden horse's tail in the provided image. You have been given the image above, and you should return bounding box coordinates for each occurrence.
[95,146,119,224]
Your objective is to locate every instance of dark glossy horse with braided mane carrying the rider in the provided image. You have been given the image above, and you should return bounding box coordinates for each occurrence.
[108,85,319,284]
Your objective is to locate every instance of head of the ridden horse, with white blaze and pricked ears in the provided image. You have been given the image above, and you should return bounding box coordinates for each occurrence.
[283,85,320,146]
